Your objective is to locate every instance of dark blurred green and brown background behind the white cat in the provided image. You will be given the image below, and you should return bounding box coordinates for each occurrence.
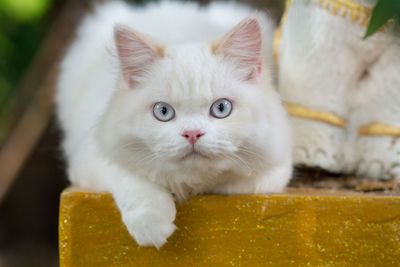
[0,0,284,267]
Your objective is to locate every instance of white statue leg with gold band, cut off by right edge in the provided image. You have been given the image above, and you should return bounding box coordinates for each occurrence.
[348,42,400,179]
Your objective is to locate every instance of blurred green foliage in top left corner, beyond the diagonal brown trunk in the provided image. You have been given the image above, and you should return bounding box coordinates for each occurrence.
[0,0,55,144]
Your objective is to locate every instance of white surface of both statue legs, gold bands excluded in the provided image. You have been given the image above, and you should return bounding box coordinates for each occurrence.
[279,0,400,181]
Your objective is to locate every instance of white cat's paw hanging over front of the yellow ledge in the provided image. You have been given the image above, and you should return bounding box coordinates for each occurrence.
[122,209,176,249]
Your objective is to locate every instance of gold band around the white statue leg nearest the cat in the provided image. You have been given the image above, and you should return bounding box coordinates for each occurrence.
[284,102,347,128]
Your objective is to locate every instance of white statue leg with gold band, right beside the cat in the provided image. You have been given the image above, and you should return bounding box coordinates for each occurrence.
[278,1,358,172]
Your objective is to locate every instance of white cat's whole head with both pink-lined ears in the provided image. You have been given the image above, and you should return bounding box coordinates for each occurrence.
[99,16,286,181]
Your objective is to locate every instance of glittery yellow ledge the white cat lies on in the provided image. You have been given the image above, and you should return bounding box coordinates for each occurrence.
[59,190,400,267]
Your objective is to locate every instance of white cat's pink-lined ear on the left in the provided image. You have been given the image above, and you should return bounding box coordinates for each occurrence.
[114,25,164,88]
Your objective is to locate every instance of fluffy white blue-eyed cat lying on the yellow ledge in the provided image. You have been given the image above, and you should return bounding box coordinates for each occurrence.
[56,2,292,248]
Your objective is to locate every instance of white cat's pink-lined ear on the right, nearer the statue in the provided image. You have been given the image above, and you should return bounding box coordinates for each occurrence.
[211,14,263,80]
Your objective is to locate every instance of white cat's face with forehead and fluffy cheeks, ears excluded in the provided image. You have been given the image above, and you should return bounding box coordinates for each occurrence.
[100,16,284,176]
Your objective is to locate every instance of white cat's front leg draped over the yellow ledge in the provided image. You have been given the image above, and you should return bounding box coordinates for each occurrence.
[69,153,176,248]
